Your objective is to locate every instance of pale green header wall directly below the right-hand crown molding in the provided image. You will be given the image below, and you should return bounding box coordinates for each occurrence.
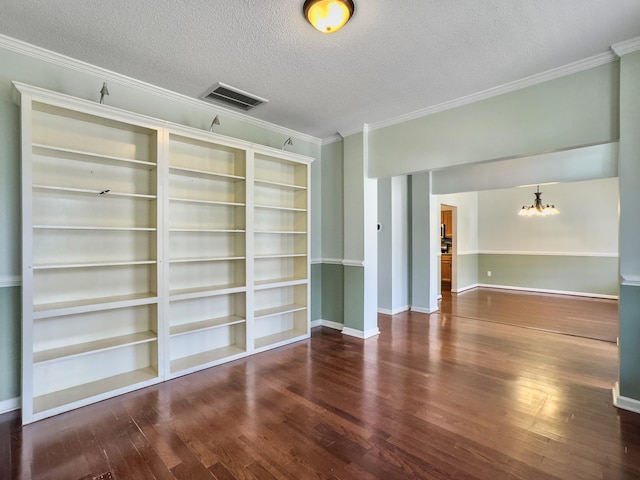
[369,62,619,178]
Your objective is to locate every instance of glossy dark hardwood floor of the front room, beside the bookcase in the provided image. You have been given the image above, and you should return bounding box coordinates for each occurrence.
[0,288,640,480]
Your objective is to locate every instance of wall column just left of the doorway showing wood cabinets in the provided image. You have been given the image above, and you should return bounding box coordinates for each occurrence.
[411,172,440,313]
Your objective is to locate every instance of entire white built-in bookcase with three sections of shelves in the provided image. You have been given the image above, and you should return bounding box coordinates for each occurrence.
[14,83,312,423]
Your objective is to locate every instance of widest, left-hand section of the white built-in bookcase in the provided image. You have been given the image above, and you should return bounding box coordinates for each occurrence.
[21,84,163,423]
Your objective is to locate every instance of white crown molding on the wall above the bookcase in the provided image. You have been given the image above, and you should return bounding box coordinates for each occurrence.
[0,34,322,145]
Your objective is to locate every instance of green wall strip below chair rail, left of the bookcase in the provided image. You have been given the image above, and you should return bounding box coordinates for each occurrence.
[0,287,21,402]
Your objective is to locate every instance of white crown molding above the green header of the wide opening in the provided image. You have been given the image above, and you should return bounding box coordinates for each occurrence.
[368,52,617,136]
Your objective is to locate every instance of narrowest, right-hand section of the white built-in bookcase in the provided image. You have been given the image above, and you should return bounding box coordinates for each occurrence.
[253,151,310,351]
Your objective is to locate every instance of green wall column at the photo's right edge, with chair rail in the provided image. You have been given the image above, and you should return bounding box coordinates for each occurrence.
[614,46,640,413]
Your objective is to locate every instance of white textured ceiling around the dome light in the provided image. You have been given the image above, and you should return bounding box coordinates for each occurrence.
[0,0,640,138]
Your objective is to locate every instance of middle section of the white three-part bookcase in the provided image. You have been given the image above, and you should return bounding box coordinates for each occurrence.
[167,132,247,375]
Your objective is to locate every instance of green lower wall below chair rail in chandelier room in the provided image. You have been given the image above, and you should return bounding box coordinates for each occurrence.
[478,254,618,296]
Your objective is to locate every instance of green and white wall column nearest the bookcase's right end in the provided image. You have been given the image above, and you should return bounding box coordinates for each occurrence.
[342,128,380,338]
